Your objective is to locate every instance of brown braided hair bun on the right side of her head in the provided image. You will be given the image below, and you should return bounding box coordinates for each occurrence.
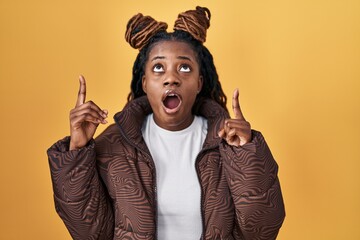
[174,6,211,43]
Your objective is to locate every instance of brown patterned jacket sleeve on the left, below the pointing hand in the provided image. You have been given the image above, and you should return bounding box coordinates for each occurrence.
[47,137,114,240]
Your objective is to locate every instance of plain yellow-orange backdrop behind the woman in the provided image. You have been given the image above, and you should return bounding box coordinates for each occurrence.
[0,0,360,240]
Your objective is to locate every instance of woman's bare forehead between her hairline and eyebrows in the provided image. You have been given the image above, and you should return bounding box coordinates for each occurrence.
[149,40,196,60]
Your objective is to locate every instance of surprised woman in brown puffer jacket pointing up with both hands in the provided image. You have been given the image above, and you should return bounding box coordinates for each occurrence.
[48,7,285,239]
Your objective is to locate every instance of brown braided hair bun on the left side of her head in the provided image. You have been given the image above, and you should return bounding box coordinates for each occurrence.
[125,13,168,50]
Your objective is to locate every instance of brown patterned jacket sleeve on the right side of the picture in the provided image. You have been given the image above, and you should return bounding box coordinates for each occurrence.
[220,130,285,240]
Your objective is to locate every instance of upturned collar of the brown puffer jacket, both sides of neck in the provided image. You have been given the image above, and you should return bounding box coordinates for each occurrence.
[114,96,229,149]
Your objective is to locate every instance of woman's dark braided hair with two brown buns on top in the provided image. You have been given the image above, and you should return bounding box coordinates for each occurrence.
[125,7,228,114]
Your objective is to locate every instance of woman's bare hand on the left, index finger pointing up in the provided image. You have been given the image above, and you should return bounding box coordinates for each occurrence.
[70,76,108,150]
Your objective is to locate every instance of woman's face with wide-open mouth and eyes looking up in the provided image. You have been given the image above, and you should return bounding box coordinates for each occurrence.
[142,41,203,131]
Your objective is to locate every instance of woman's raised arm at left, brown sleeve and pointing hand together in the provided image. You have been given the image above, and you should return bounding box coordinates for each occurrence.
[47,76,114,240]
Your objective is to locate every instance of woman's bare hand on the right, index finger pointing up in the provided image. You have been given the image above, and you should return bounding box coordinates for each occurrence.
[219,89,251,147]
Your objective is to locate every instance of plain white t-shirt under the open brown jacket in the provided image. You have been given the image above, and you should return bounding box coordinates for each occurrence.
[142,114,207,240]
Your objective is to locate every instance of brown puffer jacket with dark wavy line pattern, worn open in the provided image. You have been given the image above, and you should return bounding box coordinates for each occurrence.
[48,97,285,240]
